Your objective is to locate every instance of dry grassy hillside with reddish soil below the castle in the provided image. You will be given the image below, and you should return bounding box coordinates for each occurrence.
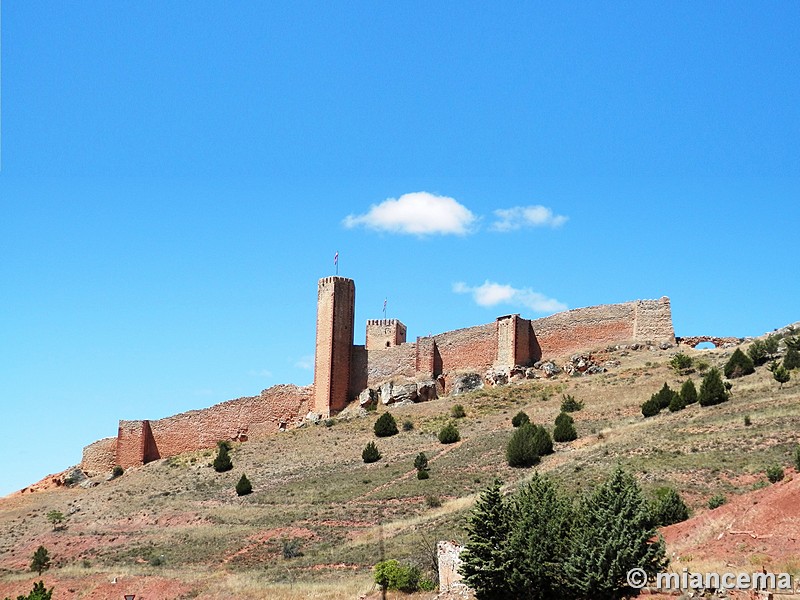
[0,338,800,599]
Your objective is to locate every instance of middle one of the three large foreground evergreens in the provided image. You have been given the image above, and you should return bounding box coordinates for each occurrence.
[508,473,574,600]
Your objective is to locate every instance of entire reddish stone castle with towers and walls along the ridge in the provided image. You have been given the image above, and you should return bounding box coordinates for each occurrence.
[81,276,675,475]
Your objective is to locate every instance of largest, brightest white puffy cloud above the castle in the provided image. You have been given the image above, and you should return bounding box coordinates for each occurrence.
[344,192,477,235]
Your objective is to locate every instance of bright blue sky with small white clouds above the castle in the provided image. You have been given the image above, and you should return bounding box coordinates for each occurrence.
[0,0,800,494]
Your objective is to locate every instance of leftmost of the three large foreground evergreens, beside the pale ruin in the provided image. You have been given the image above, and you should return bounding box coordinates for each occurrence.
[460,482,512,600]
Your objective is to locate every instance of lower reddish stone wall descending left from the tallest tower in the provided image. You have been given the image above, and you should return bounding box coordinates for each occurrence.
[111,385,312,468]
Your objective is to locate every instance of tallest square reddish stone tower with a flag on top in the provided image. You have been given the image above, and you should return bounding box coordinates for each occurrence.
[313,277,356,416]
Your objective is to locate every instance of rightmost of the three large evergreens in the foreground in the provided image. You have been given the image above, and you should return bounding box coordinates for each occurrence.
[564,467,667,600]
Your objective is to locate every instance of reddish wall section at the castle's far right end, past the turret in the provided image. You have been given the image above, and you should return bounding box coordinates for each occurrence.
[531,298,675,358]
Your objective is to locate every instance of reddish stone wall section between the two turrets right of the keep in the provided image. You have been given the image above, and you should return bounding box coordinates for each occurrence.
[434,323,497,372]
